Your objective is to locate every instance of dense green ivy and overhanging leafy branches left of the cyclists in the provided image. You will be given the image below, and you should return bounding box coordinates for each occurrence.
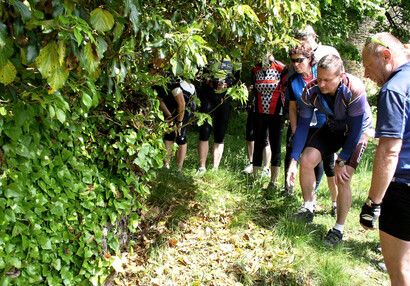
[0,0,390,285]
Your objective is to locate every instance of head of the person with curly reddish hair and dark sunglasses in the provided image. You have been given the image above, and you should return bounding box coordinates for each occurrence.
[289,41,316,73]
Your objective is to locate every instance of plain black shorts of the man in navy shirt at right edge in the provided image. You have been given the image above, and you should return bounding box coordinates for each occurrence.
[379,182,410,241]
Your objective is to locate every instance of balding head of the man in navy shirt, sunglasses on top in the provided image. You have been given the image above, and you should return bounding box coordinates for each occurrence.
[362,33,410,87]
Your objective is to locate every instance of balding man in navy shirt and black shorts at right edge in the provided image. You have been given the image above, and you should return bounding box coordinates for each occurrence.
[360,33,410,286]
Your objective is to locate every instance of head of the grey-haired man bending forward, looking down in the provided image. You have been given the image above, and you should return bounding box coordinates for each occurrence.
[317,54,344,95]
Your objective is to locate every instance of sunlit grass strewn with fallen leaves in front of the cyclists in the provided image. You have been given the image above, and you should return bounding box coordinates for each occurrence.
[116,109,389,286]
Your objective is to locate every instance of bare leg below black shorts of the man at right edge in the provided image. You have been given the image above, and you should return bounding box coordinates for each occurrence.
[379,230,410,286]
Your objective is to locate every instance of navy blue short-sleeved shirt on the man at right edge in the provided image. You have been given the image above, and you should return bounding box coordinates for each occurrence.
[375,62,410,183]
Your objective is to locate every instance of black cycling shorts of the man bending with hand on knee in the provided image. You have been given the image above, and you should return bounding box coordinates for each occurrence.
[306,124,369,169]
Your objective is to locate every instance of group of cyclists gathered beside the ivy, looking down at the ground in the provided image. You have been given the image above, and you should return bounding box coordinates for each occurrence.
[155,26,410,285]
